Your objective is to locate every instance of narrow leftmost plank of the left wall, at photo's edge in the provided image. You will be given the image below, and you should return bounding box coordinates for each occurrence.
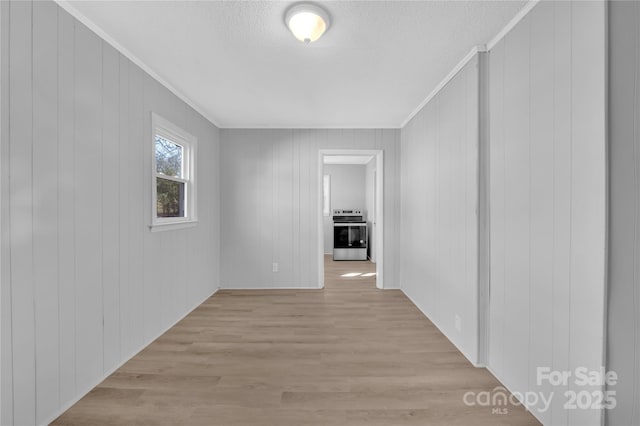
[0,2,13,424]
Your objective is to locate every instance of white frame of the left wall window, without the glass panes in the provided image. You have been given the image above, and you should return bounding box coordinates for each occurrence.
[150,112,198,232]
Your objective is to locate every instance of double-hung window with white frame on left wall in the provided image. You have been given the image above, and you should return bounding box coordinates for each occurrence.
[151,114,197,231]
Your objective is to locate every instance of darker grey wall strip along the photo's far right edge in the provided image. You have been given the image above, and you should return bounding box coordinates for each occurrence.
[606,1,640,426]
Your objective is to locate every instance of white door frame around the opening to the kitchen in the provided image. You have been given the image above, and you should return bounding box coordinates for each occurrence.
[316,149,384,289]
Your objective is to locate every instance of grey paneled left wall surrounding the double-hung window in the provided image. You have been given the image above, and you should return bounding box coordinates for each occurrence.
[0,1,219,425]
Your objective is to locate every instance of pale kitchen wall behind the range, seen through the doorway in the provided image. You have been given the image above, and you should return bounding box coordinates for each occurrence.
[323,164,367,254]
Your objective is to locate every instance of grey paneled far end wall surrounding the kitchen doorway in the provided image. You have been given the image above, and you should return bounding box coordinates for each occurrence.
[221,129,400,288]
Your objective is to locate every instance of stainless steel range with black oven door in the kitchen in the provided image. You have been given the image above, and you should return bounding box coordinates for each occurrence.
[333,209,367,260]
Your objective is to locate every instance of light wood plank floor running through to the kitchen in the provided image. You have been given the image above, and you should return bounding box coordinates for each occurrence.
[54,258,538,426]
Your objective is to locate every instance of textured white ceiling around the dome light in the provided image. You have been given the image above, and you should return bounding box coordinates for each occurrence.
[67,0,526,128]
